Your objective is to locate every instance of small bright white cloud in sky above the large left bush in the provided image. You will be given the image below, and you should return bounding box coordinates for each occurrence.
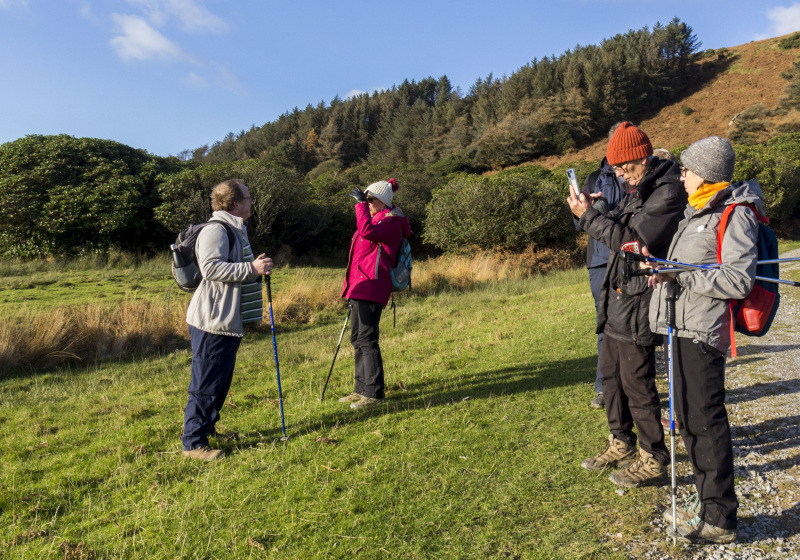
[109,14,186,62]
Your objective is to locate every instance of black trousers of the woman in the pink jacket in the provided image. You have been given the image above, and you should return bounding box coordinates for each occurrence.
[350,299,384,399]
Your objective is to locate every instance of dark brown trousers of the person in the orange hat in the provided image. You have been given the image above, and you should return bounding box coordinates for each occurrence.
[600,336,669,465]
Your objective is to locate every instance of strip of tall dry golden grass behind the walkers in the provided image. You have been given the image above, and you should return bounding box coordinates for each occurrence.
[0,249,576,374]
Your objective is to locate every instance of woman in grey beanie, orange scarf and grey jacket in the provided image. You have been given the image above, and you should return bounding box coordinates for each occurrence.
[650,136,764,543]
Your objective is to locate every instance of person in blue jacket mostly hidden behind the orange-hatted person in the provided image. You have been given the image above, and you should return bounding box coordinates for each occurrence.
[575,144,627,409]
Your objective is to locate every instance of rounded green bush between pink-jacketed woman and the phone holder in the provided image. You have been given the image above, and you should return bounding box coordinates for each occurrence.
[423,166,575,251]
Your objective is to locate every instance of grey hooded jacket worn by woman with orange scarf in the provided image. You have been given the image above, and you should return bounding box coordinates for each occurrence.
[650,180,764,352]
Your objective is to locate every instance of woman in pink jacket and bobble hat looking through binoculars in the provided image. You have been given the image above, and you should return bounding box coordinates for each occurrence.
[339,179,411,410]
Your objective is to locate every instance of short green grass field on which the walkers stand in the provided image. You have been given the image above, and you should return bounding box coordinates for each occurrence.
[0,245,796,559]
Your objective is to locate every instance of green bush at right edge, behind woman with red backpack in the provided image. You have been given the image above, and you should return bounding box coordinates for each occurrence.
[733,133,800,222]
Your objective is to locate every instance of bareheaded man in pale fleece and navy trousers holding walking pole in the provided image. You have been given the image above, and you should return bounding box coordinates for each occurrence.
[181,179,272,461]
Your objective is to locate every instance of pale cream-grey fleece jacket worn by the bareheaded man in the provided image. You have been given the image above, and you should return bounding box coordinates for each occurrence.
[186,210,258,337]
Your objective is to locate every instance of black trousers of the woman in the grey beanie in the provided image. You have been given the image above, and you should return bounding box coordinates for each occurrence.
[673,337,739,529]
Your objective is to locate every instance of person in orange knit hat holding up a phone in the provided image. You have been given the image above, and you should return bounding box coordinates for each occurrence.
[567,122,686,488]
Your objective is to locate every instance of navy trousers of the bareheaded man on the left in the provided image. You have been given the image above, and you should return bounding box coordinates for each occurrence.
[181,326,242,451]
